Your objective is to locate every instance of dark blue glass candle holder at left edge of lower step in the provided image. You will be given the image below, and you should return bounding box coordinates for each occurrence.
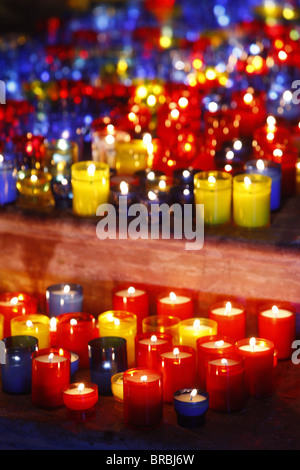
[1,335,38,395]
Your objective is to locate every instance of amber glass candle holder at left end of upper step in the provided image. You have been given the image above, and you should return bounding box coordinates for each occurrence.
[16,169,55,209]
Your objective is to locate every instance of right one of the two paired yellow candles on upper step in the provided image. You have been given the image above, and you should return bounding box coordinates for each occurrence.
[233,174,272,228]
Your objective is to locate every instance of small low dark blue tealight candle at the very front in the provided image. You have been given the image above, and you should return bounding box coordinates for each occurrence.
[173,388,209,428]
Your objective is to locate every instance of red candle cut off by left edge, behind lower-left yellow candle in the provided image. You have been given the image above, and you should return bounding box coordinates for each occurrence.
[0,292,37,337]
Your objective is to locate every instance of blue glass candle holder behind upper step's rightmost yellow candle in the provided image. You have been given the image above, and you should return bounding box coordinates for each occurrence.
[245,159,281,211]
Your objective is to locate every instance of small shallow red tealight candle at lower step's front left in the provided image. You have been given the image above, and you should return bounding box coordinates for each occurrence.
[62,382,98,411]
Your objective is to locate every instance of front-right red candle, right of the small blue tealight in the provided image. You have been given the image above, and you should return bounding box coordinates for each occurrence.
[206,356,246,413]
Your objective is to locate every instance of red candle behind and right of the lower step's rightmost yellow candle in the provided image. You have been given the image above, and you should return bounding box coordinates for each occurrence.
[208,301,246,341]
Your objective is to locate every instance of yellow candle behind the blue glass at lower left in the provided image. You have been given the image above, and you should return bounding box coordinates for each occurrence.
[10,313,50,349]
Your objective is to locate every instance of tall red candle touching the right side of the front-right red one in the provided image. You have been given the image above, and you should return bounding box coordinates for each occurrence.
[236,338,274,398]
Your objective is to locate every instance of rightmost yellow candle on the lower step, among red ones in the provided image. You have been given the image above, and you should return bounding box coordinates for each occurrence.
[178,318,218,349]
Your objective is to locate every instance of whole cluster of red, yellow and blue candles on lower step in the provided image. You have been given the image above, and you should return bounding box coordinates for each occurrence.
[0,284,295,428]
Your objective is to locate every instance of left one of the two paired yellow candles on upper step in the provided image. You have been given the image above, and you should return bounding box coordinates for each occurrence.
[194,171,232,225]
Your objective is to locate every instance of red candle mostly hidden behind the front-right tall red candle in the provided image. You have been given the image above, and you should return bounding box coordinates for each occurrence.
[197,335,235,390]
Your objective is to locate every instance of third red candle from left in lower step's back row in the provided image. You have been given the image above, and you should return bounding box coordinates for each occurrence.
[156,292,194,320]
